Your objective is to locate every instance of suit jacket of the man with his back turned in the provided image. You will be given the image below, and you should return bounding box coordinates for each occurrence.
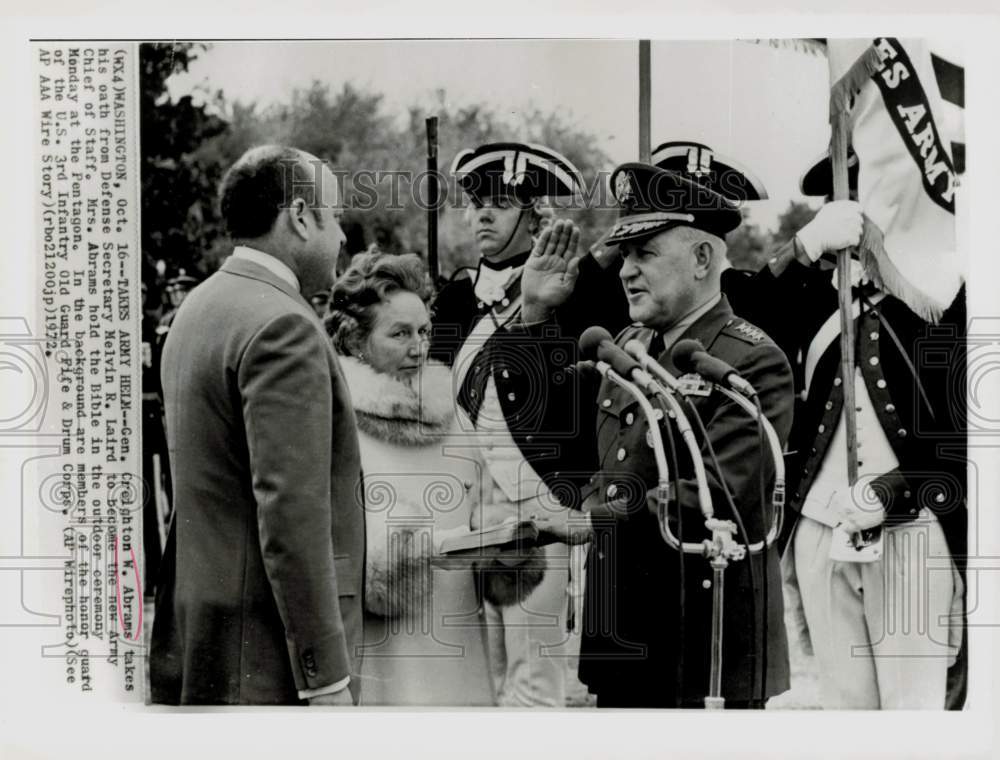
[150,258,365,704]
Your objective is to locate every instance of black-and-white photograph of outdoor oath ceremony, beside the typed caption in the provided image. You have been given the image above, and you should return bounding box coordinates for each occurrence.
[140,37,969,710]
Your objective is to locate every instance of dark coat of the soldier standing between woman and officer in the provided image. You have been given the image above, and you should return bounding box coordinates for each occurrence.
[430,255,628,507]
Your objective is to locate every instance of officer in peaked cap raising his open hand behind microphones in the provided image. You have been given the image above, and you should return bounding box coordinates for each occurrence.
[524,163,792,707]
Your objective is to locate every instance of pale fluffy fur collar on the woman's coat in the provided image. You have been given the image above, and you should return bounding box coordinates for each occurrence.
[340,356,455,446]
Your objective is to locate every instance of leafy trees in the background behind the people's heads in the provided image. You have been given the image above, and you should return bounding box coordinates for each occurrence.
[141,43,814,285]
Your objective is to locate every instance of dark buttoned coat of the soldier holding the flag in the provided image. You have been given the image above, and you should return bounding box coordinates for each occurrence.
[729,252,967,572]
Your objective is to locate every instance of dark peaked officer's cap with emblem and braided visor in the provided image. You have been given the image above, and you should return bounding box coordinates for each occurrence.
[604,163,742,245]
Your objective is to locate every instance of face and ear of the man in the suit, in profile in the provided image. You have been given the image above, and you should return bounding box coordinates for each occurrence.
[299,163,347,293]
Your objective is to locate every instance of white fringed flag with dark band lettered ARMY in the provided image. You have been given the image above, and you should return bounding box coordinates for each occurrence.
[827,37,964,322]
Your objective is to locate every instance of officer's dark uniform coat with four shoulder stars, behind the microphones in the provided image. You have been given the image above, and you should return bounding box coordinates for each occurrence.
[580,297,792,707]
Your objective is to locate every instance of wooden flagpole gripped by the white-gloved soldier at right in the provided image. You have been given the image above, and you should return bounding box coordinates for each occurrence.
[830,109,858,486]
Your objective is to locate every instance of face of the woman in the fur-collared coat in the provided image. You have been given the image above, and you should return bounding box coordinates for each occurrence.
[362,290,431,380]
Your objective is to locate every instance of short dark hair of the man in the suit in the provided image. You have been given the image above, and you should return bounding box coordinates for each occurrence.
[219,145,322,240]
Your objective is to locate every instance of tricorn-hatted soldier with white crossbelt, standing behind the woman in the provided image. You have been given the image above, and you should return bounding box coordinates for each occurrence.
[431,142,625,707]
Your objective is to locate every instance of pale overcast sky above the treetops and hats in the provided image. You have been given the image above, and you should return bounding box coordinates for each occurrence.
[169,40,829,228]
